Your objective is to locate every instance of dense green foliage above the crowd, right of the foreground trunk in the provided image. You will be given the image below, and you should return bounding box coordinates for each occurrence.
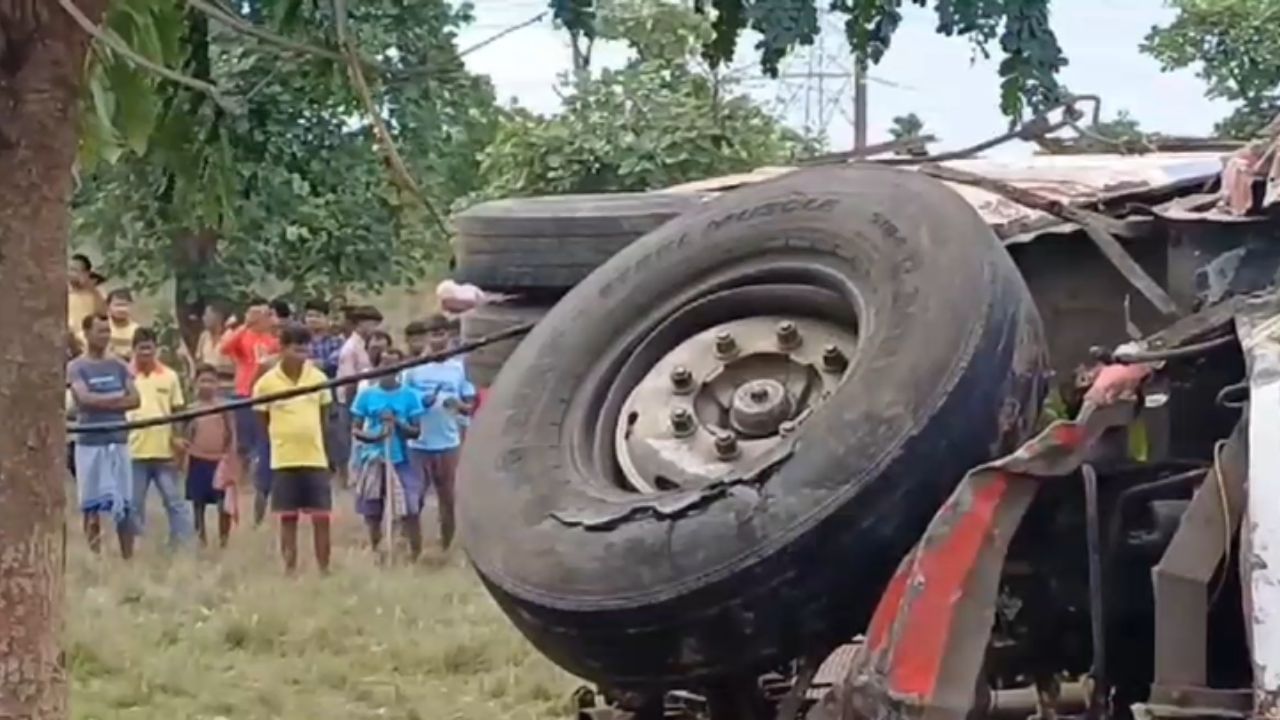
[76,0,497,302]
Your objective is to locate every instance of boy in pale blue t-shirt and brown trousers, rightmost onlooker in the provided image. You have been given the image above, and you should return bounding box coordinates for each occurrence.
[404,314,476,550]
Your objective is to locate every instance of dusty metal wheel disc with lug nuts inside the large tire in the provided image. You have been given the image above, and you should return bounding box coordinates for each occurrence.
[614,315,858,492]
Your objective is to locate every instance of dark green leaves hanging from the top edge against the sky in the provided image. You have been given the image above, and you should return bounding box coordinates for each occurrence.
[552,0,1066,122]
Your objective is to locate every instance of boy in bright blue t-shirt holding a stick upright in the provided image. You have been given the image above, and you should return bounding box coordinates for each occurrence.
[351,347,426,560]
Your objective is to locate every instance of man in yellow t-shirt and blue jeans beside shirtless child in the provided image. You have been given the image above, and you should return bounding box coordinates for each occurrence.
[128,328,192,546]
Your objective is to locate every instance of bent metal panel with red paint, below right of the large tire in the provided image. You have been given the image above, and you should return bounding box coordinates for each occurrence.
[810,404,1134,720]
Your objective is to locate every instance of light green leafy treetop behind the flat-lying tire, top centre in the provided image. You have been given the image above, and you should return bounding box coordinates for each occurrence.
[477,0,813,199]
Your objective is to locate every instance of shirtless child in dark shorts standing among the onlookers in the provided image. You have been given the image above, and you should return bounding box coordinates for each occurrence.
[187,364,239,547]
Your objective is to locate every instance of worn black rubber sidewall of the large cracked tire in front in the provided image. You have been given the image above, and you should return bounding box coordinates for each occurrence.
[458,168,1016,610]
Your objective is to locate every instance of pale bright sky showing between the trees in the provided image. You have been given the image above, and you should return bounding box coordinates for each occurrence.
[458,0,1229,155]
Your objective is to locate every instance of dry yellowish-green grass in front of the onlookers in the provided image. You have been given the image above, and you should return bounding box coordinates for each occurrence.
[67,486,577,720]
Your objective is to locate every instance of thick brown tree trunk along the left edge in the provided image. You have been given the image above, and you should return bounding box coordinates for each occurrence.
[0,0,106,720]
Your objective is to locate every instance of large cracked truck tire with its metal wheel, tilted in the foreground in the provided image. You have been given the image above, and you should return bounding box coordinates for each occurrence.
[458,165,1047,689]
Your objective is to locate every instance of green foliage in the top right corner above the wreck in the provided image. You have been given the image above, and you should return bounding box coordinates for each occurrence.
[1143,0,1280,138]
